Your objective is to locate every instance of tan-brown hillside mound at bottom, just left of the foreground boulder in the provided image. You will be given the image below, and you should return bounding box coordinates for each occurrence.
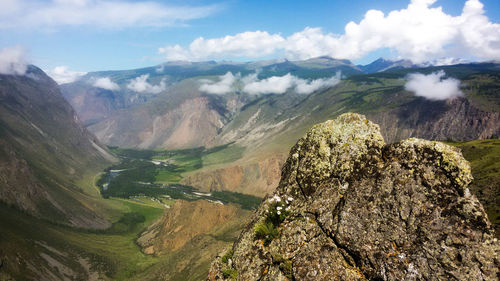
[131,200,251,280]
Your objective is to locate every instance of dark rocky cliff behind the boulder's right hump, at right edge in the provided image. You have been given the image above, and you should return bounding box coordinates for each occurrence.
[367,98,500,142]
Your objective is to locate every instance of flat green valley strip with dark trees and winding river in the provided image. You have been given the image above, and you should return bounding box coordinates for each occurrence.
[97,145,261,210]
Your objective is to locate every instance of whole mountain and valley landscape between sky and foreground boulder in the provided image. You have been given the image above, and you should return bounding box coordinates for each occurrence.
[0,57,500,280]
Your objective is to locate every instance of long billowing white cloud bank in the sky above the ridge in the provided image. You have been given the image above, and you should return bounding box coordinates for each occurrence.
[158,0,500,63]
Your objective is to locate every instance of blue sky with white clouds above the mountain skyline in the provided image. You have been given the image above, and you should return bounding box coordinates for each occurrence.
[0,0,500,76]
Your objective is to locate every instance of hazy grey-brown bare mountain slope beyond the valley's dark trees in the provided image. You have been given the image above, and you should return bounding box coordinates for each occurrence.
[88,79,241,149]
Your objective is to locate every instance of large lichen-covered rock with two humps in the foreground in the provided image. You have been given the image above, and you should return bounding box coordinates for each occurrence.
[208,113,500,280]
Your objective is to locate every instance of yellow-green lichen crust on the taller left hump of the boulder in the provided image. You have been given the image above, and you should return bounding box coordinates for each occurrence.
[289,113,385,195]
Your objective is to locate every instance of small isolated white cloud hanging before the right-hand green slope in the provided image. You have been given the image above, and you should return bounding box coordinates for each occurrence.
[405,70,463,100]
